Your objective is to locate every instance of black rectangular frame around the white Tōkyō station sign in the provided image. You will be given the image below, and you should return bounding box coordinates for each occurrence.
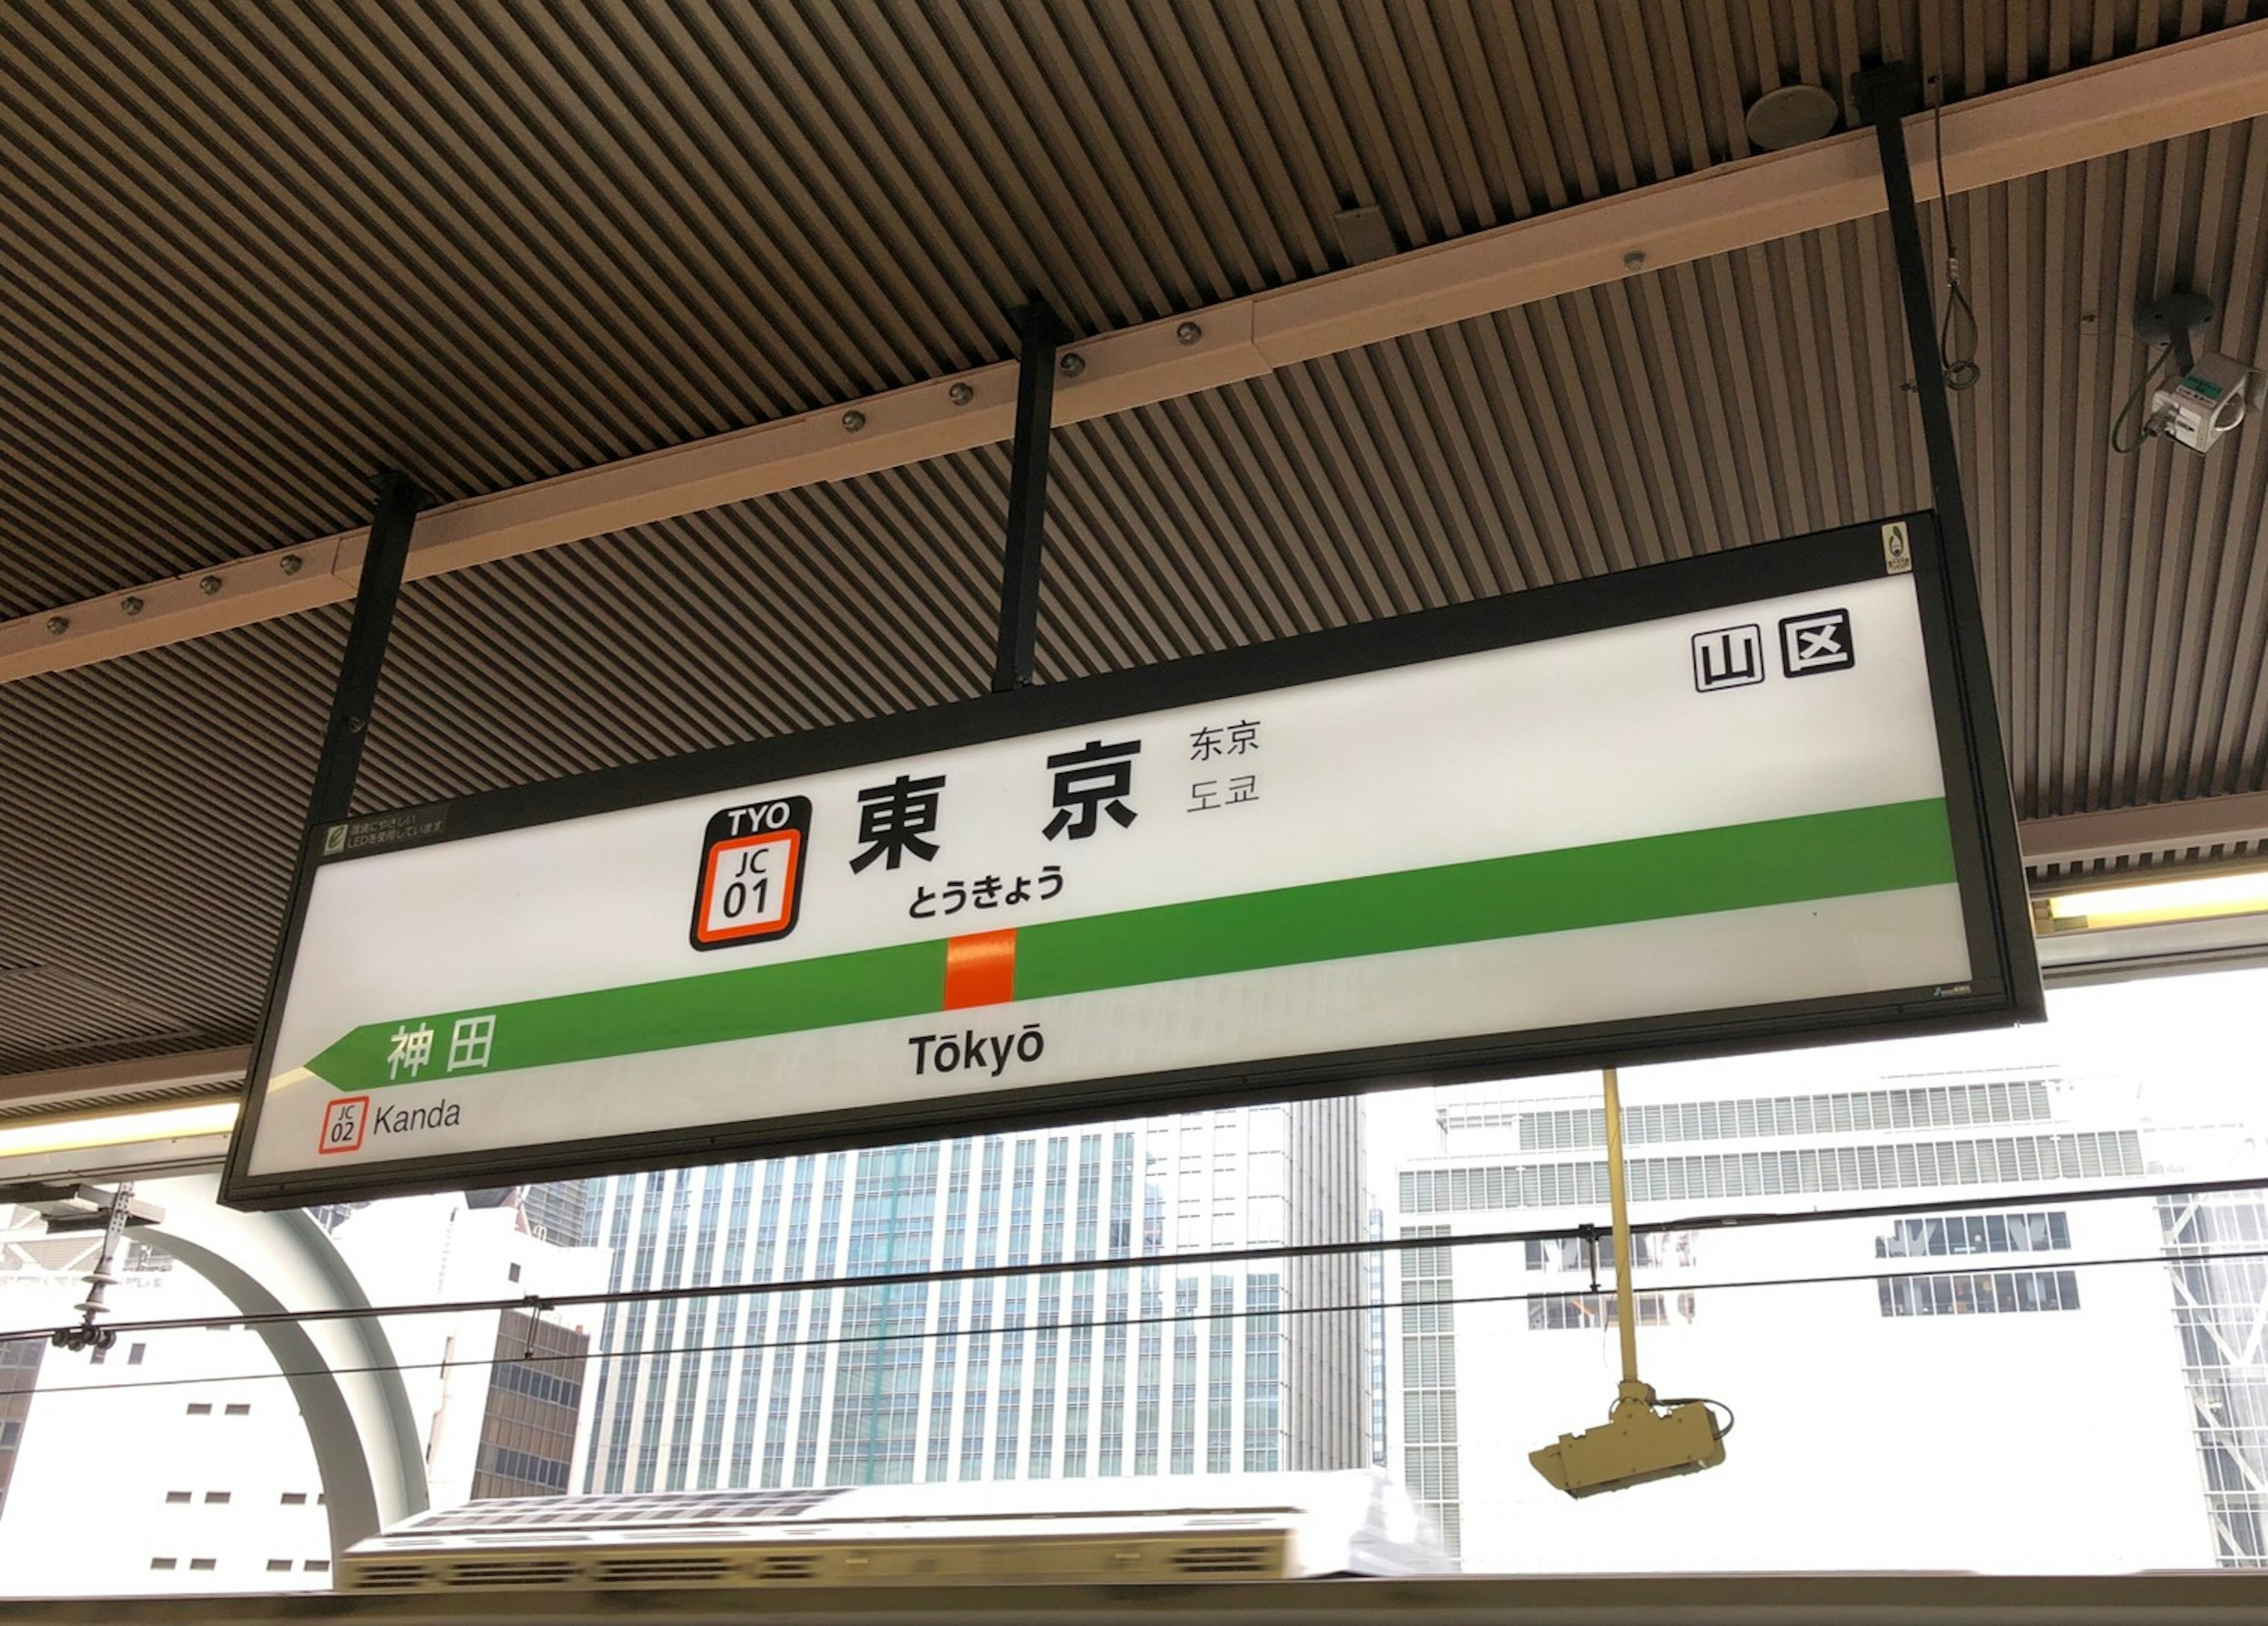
[220,513,2046,1209]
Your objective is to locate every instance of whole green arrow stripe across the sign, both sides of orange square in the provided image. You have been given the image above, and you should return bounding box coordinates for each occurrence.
[308,799,1955,1091]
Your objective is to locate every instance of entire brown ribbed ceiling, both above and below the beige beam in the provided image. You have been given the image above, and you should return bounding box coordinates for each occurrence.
[0,12,2268,1073]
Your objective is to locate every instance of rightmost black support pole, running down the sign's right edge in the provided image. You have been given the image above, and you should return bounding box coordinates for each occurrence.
[1850,64,2046,1018]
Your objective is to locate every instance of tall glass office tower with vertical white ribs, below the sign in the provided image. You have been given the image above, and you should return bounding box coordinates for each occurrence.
[576,1100,1370,1492]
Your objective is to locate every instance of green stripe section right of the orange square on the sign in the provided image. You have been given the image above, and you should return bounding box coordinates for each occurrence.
[1016,799,1953,1000]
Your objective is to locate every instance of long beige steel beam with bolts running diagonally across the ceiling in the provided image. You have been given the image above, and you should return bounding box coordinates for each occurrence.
[0,21,2268,683]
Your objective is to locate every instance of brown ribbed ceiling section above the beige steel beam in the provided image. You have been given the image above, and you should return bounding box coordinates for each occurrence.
[0,0,2246,617]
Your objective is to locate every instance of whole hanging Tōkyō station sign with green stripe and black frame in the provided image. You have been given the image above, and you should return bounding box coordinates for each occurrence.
[224,515,2039,1207]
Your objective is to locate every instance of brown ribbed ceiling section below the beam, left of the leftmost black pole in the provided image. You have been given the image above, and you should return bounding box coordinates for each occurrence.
[0,610,347,1073]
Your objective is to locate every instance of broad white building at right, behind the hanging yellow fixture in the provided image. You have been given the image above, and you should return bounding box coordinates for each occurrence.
[1388,1057,2231,1572]
